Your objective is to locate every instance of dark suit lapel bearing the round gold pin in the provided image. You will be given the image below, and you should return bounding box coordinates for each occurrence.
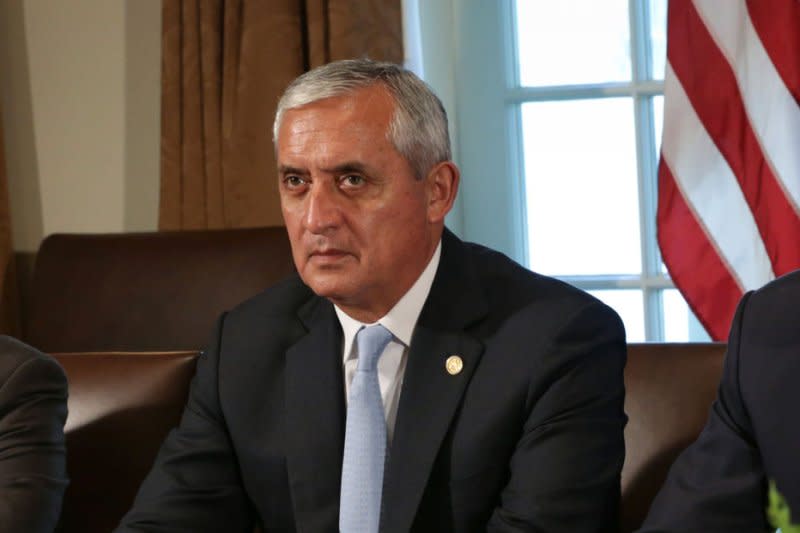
[381,231,487,532]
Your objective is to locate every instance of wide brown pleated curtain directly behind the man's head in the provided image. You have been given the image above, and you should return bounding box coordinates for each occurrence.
[159,0,403,230]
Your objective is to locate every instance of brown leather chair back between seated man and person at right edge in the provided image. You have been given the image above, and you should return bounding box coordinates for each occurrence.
[621,343,725,533]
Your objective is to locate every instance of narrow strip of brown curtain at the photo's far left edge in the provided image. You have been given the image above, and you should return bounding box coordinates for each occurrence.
[0,106,19,336]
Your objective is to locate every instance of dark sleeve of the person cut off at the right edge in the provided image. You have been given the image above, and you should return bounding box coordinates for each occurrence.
[640,293,768,533]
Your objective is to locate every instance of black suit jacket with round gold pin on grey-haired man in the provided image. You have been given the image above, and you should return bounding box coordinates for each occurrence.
[119,232,626,533]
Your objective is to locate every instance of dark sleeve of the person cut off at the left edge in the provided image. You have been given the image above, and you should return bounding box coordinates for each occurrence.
[0,335,67,533]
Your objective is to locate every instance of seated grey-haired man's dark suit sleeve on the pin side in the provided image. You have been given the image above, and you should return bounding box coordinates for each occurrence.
[487,302,627,533]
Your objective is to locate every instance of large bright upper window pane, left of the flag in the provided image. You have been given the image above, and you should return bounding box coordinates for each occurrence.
[520,0,631,86]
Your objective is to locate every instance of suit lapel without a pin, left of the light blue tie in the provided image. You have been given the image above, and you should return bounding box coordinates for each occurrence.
[285,298,345,531]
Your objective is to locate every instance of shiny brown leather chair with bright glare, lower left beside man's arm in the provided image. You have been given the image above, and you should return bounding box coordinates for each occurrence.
[54,352,197,533]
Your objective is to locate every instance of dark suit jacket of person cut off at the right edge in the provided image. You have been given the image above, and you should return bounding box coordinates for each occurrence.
[641,271,800,533]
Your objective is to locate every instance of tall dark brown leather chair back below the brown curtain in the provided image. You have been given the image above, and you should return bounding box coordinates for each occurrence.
[23,227,294,353]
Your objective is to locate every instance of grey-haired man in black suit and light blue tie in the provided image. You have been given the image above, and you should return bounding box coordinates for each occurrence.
[120,60,625,533]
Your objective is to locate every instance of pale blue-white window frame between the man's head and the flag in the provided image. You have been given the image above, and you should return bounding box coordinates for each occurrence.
[405,0,708,341]
